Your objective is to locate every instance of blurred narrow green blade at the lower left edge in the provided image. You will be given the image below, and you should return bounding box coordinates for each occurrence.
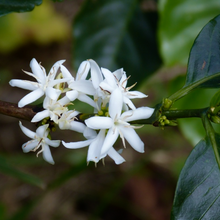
[0,155,44,188]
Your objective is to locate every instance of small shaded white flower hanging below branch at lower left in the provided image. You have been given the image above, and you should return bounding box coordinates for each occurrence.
[19,122,60,164]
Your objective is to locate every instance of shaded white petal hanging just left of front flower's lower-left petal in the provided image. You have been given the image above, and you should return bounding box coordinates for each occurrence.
[87,130,105,163]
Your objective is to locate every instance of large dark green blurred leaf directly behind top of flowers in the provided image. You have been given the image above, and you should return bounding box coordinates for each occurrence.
[73,0,161,84]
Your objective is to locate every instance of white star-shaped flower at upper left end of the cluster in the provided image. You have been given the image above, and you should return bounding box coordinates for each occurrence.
[9,58,67,107]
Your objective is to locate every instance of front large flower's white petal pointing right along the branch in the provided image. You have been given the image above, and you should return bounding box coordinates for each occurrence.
[121,107,154,121]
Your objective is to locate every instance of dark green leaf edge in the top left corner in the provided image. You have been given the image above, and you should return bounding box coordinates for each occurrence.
[0,0,42,17]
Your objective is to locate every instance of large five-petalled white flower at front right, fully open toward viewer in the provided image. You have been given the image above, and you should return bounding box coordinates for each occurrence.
[85,88,154,155]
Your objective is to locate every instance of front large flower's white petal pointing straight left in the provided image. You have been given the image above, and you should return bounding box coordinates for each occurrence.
[85,116,113,129]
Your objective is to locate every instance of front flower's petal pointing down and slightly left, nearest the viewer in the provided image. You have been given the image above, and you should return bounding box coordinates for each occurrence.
[101,128,119,155]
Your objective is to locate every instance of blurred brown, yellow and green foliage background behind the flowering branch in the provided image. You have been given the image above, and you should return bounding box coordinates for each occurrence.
[0,0,220,220]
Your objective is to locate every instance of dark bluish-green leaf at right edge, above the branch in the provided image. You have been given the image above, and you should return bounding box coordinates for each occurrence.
[184,16,220,88]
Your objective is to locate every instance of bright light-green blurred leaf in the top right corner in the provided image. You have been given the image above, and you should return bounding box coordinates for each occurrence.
[158,0,220,65]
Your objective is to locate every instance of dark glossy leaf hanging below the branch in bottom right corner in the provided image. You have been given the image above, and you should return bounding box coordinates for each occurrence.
[171,134,220,220]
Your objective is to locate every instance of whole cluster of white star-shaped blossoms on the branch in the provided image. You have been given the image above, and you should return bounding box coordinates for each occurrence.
[9,59,154,164]
